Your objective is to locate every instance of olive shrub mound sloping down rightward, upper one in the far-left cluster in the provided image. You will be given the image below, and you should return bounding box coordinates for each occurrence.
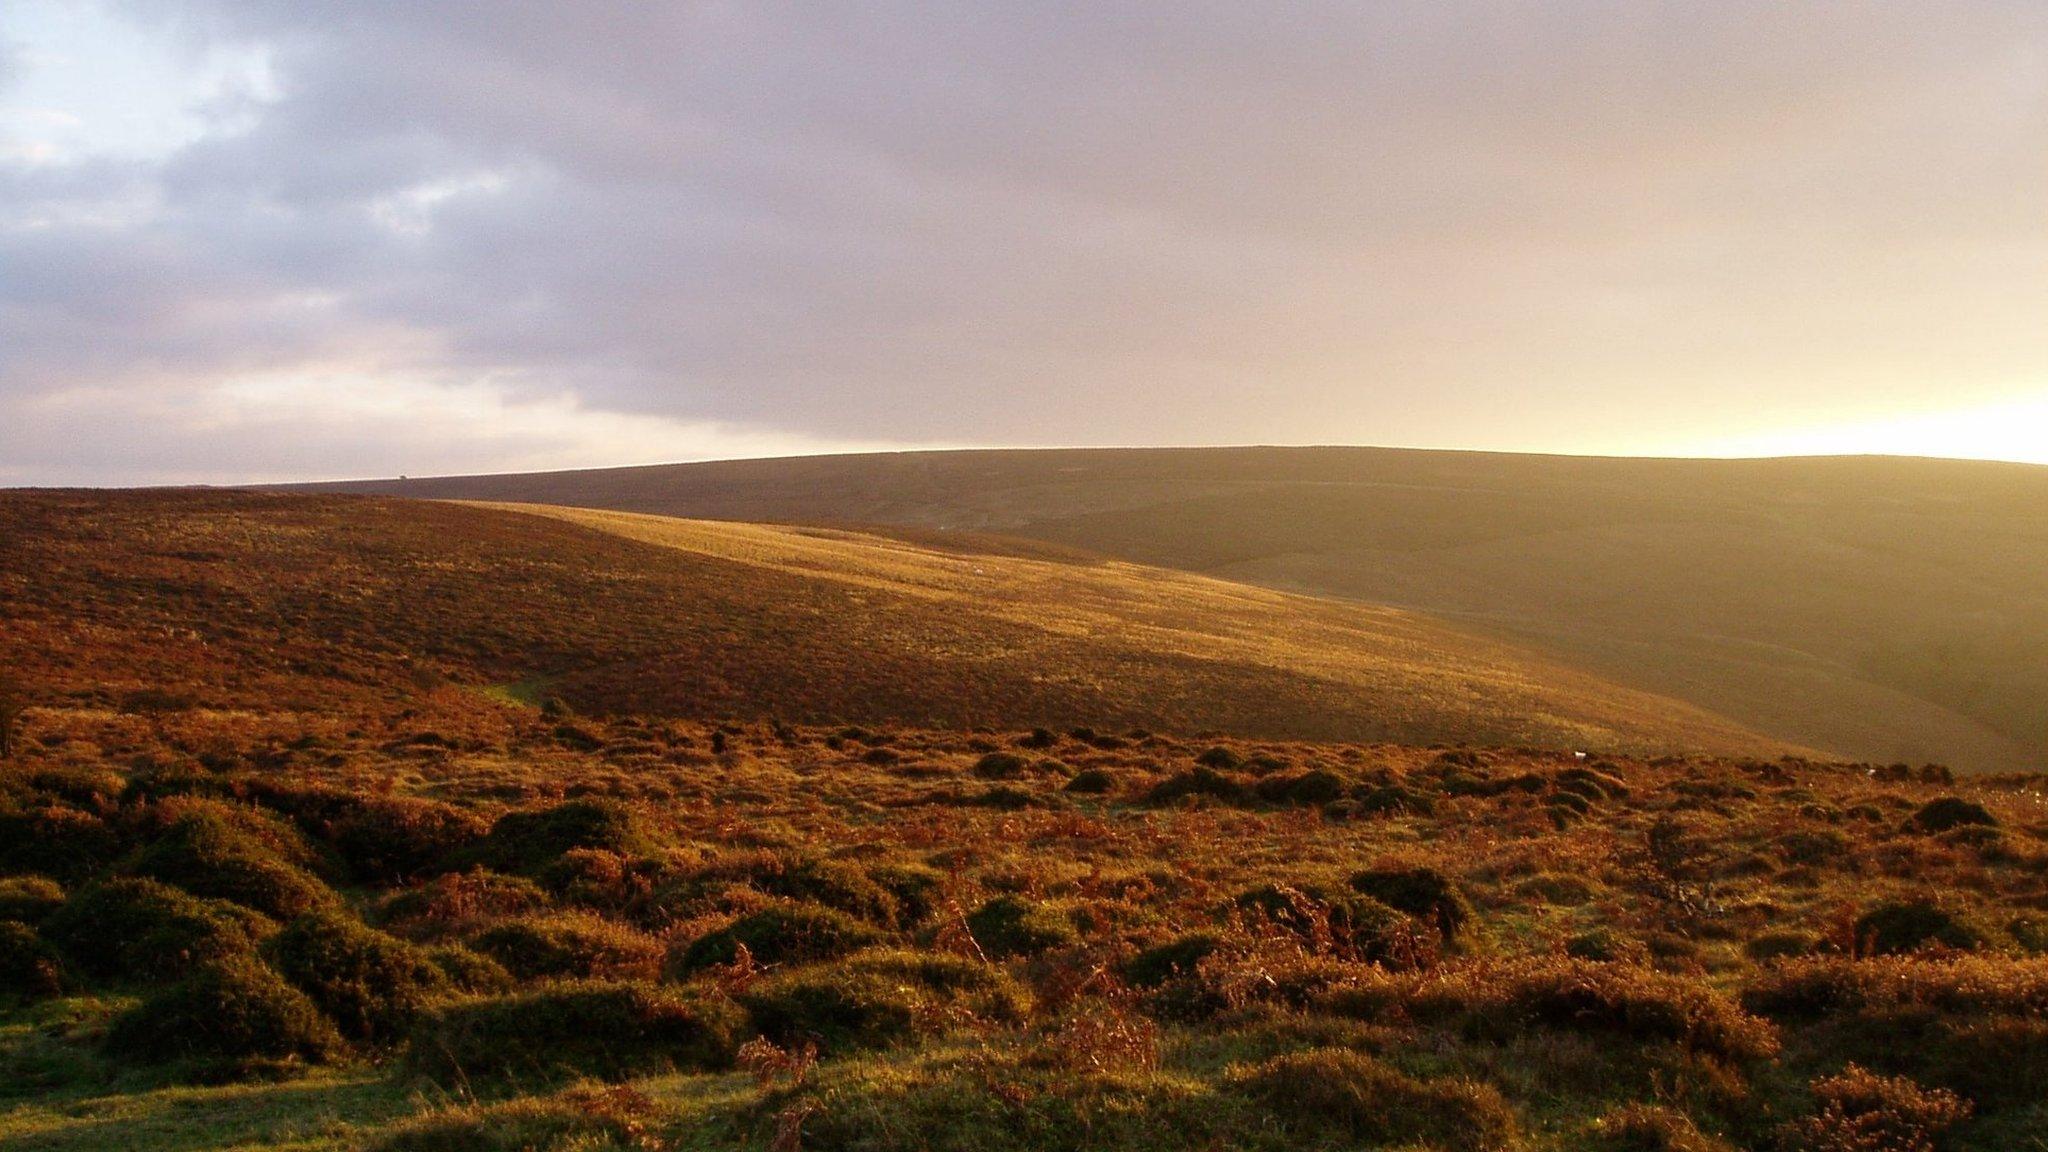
[129,810,334,920]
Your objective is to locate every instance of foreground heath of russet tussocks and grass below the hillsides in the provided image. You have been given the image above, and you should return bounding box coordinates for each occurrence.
[0,687,2048,1152]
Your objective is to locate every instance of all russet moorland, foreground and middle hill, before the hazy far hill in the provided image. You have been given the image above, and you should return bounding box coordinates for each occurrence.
[0,492,2048,1152]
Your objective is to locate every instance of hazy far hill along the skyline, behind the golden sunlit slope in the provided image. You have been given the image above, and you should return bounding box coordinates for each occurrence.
[303,449,2048,769]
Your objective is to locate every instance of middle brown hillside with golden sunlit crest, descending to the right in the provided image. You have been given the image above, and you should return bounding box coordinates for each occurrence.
[0,492,1784,754]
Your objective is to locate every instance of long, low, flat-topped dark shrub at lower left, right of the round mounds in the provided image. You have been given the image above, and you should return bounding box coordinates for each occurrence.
[406,982,739,1084]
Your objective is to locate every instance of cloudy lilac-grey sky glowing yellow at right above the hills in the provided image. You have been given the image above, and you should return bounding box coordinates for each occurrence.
[0,0,2048,486]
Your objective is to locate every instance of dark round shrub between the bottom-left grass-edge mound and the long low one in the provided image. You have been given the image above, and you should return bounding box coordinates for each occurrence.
[266,912,453,1041]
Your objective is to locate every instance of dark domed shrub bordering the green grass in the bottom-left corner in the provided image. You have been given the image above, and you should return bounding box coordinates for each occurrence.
[106,957,346,1068]
